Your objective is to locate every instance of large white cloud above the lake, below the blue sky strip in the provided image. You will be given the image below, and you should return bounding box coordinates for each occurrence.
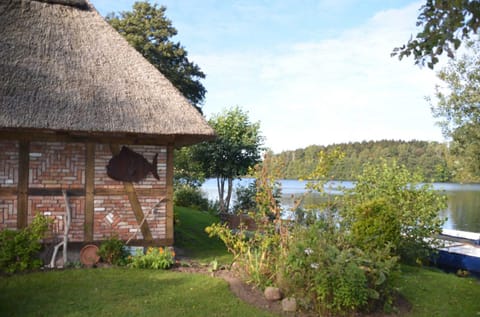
[192,3,441,152]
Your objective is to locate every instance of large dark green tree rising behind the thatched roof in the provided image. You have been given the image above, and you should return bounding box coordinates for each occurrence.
[106,1,206,111]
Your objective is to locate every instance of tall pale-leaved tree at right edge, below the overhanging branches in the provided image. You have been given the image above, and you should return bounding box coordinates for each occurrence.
[432,42,480,181]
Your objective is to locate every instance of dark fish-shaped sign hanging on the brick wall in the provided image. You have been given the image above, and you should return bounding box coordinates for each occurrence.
[107,146,160,183]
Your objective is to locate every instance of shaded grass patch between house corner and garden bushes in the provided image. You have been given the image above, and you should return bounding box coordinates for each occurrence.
[175,207,232,263]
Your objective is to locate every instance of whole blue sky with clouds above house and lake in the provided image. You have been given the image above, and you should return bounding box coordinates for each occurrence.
[90,0,443,153]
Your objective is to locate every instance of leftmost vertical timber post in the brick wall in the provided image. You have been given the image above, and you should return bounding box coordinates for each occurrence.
[17,141,30,229]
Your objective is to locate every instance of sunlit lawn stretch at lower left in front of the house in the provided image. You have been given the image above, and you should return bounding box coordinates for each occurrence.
[0,268,273,317]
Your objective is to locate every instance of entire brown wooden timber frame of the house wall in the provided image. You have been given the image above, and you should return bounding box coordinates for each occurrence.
[0,131,175,246]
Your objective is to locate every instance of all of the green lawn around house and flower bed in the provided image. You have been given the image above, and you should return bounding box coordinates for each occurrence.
[0,208,480,317]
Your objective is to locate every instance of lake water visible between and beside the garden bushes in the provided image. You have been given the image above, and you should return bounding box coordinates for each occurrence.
[202,178,480,232]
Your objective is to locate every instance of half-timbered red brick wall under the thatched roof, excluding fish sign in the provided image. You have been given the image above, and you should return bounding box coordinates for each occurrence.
[0,140,173,242]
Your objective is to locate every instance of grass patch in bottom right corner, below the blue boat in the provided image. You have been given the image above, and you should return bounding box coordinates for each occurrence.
[398,266,480,317]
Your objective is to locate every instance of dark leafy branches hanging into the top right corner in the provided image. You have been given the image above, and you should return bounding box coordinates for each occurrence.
[392,0,480,69]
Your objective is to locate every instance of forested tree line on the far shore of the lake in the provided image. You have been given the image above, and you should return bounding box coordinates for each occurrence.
[271,140,464,182]
